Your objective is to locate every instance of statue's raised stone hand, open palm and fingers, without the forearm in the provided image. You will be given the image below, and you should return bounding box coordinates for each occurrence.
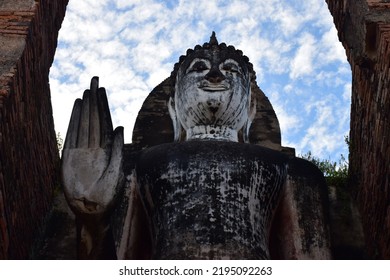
[61,77,123,216]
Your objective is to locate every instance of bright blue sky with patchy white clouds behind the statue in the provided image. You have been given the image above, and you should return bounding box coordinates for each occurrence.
[50,0,351,160]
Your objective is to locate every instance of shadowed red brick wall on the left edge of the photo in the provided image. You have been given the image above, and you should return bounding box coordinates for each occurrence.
[0,0,68,259]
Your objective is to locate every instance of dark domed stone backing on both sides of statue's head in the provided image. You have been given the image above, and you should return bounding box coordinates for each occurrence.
[132,77,284,151]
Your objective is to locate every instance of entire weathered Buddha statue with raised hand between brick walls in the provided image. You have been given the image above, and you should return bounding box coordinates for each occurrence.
[62,32,331,259]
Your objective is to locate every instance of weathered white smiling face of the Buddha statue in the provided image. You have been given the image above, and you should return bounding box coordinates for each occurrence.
[175,50,250,140]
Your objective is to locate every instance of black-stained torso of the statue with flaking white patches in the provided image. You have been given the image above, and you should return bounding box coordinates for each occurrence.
[137,141,287,259]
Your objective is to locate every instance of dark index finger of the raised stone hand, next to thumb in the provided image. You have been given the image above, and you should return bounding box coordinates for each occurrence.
[97,88,113,148]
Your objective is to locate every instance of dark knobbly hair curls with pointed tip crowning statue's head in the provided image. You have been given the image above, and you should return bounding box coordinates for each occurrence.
[171,31,256,91]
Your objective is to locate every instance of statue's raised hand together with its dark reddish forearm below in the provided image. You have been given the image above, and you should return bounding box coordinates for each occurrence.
[61,77,124,259]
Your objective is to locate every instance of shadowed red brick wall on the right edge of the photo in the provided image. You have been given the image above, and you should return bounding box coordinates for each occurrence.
[327,0,390,259]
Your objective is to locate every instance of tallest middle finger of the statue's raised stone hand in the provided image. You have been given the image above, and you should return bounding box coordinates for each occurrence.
[88,77,100,148]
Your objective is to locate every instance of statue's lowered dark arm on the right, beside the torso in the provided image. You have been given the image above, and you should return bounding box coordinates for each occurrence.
[270,157,333,259]
